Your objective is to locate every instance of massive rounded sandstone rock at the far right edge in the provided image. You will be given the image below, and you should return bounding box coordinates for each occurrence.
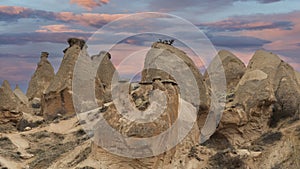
[219,50,300,145]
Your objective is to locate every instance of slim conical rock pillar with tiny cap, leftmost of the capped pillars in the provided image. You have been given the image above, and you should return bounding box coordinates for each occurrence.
[26,52,55,101]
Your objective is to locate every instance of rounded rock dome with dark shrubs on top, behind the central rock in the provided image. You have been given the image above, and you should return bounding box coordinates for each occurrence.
[142,43,209,110]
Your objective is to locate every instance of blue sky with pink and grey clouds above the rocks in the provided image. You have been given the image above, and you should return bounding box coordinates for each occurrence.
[0,0,300,92]
